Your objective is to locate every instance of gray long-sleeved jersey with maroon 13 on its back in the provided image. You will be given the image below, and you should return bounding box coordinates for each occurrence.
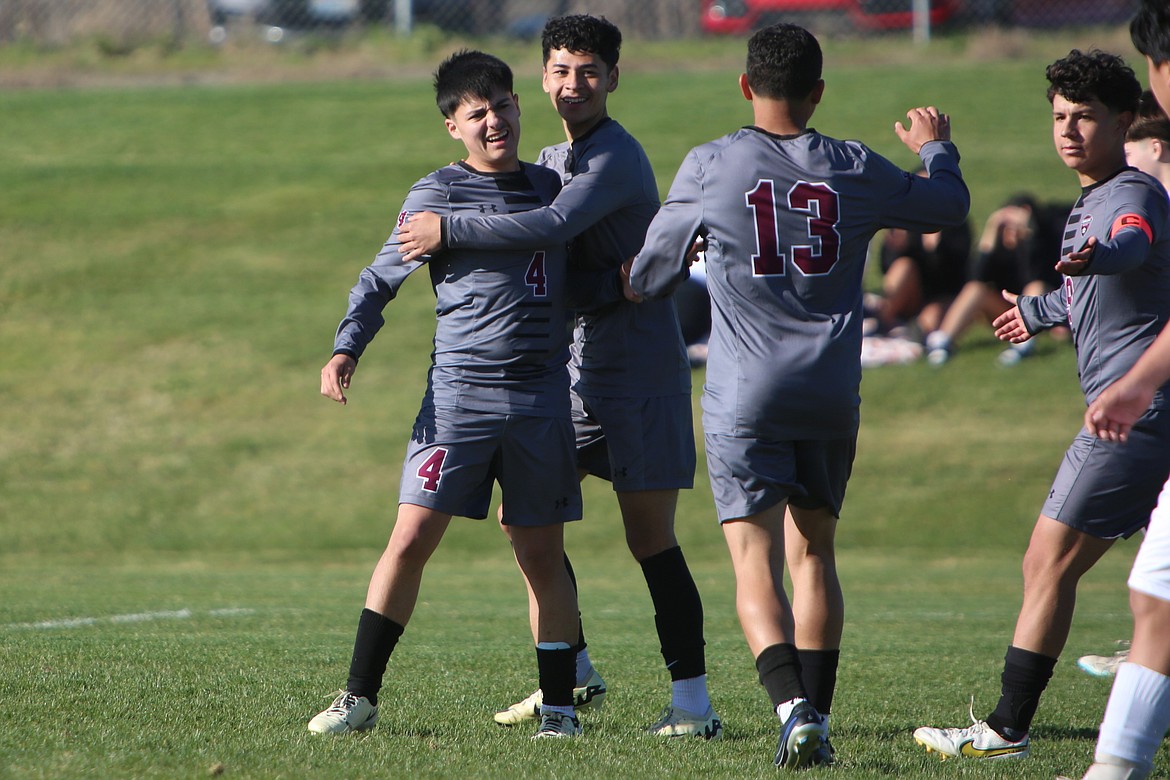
[631,127,970,440]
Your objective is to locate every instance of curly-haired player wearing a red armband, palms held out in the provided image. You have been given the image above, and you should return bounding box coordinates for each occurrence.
[914,49,1170,759]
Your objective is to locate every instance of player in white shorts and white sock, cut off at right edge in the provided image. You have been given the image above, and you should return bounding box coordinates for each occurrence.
[1062,0,1170,780]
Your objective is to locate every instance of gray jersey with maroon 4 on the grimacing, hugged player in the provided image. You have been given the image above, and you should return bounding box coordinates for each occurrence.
[333,164,569,416]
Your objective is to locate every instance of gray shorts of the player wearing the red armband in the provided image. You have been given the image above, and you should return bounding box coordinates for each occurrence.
[1042,410,1170,539]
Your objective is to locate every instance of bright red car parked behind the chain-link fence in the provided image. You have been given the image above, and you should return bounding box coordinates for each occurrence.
[700,0,958,35]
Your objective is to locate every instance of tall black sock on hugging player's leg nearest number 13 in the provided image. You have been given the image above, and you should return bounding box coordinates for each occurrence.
[641,547,707,679]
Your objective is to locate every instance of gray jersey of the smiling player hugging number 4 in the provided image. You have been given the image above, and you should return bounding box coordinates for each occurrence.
[443,119,690,398]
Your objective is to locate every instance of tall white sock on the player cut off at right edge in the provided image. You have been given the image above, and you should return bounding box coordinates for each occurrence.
[1096,663,1170,768]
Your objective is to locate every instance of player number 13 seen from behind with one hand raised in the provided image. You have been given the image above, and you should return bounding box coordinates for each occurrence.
[629,25,970,769]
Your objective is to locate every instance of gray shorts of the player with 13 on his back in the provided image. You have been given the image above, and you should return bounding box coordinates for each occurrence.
[704,434,858,523]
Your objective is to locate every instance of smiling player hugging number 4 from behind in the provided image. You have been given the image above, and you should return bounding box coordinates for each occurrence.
[401,15,723,739]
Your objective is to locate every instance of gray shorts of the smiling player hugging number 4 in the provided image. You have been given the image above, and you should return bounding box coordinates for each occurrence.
[570,391,695,492]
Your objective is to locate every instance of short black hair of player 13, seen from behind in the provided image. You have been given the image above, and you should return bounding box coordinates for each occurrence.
[746,23,825,101]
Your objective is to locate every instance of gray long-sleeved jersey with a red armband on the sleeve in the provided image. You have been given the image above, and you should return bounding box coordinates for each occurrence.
[1018,168,1170,409]
